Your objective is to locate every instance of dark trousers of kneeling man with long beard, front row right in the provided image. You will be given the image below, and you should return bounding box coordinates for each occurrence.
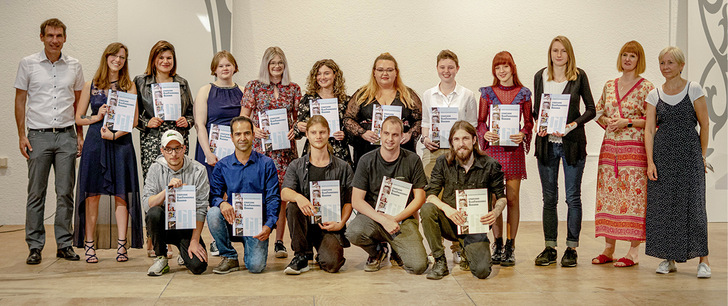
[420,202,491,279]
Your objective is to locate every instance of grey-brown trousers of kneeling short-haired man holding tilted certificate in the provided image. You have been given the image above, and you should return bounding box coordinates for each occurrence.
[346,214,428,274]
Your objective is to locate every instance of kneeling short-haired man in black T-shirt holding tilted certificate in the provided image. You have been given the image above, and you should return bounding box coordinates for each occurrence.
[346,116,427,274]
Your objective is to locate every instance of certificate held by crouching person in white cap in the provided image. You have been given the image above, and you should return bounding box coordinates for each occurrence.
[164,185,197,230]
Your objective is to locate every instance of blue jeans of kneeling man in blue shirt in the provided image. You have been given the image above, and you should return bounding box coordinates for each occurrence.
[207,207,268,273]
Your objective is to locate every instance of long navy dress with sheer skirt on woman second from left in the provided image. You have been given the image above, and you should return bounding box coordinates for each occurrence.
[73,82,143,248]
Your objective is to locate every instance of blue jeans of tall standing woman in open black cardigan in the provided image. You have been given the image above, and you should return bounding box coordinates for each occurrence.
[538,143,586,248]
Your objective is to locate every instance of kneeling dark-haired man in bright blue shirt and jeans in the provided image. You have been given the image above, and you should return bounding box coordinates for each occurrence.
[207,116,281,274]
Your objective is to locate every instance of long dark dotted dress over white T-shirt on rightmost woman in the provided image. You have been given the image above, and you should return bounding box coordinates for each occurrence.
[645,84,708,262]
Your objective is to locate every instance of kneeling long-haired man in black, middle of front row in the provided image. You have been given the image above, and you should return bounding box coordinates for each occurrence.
[281,115,354,275]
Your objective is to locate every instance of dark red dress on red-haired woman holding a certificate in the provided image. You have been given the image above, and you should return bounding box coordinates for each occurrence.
[477,86,533,180]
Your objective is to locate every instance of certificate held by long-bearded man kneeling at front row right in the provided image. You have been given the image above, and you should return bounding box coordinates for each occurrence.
[455,189,488,235]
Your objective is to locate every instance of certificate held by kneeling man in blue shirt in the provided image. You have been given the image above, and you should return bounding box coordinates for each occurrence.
[232,193,263,237]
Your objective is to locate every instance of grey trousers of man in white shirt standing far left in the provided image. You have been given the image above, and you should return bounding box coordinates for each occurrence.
[25,130,77,250]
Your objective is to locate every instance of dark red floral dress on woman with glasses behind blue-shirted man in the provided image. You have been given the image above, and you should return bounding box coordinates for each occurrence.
[241,80,301,186]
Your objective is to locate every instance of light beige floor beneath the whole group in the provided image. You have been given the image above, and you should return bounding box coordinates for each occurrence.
[0,222,728,305]
